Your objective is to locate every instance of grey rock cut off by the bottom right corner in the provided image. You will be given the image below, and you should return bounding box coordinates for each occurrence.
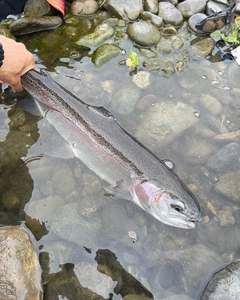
[200,261,240,300]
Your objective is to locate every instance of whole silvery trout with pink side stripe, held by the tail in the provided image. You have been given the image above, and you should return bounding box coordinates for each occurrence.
[21,70,202,229]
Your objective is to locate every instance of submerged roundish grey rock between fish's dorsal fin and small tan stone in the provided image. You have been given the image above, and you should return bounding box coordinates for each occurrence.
[111,84,141,115]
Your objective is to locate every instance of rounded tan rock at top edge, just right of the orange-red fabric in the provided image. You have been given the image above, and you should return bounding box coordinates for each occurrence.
[71,0,99,16]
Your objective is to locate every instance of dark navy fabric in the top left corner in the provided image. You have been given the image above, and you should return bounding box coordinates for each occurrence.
[0,0,26,19]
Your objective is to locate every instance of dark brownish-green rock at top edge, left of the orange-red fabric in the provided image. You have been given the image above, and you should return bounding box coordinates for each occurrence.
[24,0,52,17]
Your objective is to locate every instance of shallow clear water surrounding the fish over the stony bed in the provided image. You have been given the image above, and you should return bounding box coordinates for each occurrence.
[0,16,240,299]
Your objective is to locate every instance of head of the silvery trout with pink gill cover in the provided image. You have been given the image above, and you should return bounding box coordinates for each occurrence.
[134,181,202,229]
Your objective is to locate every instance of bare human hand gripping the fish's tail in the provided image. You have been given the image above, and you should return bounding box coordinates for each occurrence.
[0,35,36,91]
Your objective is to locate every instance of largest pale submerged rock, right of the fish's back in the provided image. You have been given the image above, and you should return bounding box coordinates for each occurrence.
[136,101,197,149]
